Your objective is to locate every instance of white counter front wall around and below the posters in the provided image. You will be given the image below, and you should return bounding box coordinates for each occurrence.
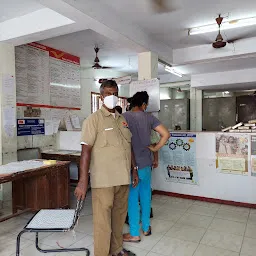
[152,132,256,204]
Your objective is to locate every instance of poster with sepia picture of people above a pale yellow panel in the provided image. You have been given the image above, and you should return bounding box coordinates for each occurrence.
[216,133,249,175]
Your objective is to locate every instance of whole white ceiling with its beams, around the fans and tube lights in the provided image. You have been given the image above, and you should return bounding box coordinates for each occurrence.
[0,0,256,86]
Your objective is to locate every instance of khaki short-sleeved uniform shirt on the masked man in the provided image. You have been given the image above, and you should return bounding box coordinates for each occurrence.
[81,107,132,188]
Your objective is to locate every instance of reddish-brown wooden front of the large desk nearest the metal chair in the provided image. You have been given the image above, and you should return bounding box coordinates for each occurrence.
[0,160,70,222]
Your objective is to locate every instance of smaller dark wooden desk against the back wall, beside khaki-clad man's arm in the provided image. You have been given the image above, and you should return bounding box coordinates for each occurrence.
[41,150,81,183]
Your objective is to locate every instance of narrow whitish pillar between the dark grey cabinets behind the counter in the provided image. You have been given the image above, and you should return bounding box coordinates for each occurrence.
[190,88,203,132]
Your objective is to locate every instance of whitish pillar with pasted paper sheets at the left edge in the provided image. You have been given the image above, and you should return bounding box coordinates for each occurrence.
[0,43,17,206]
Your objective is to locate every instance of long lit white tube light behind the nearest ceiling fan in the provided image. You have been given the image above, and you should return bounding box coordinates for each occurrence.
[188,17,256,35]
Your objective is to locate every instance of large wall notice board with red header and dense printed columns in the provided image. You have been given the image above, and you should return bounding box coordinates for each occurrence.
[15,43,81,108]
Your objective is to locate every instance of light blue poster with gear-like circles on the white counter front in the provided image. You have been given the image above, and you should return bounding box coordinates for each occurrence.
[160,133,198,185]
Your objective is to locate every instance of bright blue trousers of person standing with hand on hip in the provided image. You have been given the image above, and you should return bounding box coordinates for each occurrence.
[128,166,151,236]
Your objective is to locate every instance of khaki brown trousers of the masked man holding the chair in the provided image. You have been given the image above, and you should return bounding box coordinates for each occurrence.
[92,185,129,256]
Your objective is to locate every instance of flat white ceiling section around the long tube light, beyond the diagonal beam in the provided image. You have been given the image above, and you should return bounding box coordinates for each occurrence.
[101,0,256,48]
